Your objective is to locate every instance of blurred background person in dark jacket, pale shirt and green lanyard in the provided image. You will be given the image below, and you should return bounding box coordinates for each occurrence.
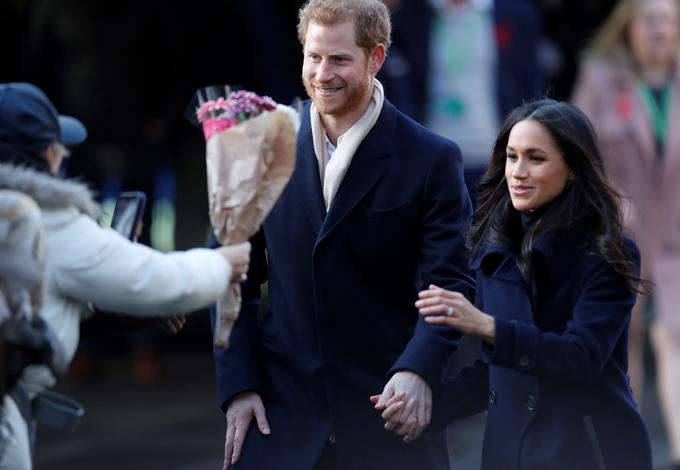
[380,0,543,203]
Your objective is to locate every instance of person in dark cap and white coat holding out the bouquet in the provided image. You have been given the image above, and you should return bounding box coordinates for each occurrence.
[0,83,250,469]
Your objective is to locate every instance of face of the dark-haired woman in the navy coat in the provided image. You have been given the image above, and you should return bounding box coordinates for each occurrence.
[505,120,572,211]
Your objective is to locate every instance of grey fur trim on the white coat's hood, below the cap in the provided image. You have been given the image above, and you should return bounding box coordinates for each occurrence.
[0,163,101,219]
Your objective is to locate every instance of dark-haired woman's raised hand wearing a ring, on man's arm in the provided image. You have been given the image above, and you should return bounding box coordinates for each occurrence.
[416,284,496,344]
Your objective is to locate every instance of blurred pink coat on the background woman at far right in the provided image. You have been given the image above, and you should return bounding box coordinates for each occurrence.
[573,59,680,333]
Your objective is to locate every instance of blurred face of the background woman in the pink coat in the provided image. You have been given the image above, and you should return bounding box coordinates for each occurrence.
[629,0,680,66]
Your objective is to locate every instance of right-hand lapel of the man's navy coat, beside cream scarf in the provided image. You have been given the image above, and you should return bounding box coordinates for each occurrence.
[317,101,396,242]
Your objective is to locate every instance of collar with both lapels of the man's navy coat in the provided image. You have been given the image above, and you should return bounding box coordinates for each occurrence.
[293,100,397,241]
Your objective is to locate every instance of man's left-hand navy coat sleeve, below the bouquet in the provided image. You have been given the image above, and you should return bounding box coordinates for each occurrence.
[210,230,267,412]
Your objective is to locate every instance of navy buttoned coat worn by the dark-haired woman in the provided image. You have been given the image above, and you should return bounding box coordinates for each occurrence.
[434,232,652,470]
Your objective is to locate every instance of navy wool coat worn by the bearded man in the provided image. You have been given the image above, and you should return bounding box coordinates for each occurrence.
[215,101,474,470]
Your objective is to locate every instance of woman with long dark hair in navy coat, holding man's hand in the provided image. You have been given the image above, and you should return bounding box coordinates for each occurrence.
[383,100,652,470]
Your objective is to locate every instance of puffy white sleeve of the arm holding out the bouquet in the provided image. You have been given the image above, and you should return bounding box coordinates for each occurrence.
[47,216,231,316]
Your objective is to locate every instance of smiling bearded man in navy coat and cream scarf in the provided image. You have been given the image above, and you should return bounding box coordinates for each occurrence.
[215,0,473,470]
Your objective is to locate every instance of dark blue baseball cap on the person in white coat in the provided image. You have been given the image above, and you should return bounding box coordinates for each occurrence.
[0,83,87,152]
